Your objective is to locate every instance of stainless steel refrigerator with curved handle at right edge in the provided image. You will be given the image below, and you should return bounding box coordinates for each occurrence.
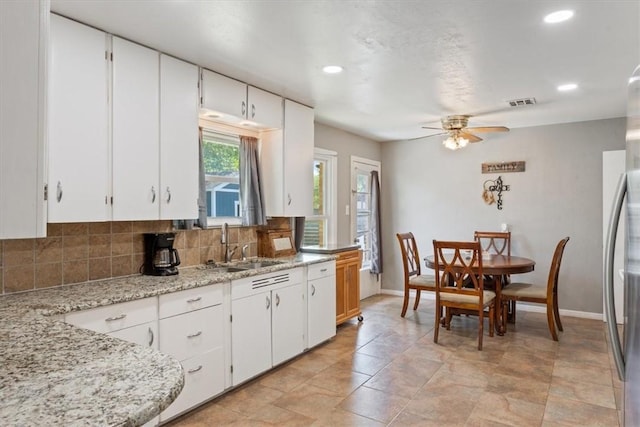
[603,66,640,427]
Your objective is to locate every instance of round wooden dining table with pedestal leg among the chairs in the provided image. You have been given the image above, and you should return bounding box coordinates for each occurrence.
[424,255,536,335]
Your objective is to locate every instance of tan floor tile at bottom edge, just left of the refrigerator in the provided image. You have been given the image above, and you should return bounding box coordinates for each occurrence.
[543,395,618,427]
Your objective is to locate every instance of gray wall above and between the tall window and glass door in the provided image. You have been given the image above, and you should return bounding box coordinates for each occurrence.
[314,123,384,242]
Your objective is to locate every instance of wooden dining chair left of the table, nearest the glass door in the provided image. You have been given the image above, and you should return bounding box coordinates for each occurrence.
[396,233,436,317]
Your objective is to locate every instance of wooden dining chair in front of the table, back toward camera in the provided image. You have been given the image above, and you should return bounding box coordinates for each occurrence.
[433,240,496,350]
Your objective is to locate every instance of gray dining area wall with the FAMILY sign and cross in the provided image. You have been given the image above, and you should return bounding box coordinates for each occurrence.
[380,118,626,313]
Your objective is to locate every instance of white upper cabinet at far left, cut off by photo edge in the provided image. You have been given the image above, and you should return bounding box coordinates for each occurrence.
[0,0,49,239]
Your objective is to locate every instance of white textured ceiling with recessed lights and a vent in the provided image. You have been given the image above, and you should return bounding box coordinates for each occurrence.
[51,0,640,141]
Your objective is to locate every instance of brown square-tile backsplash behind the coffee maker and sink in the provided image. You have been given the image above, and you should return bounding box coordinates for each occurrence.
[0,221,257,294]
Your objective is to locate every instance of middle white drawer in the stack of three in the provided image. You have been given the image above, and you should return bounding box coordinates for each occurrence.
[160,305,224,360]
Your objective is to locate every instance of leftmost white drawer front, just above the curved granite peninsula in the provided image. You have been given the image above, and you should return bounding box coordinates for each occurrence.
[65,297,158,333]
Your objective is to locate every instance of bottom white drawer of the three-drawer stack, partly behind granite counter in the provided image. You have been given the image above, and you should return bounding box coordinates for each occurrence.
[160,348,224,422]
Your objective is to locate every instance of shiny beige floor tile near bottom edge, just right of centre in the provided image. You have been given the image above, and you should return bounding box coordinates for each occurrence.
[340,387,409,423]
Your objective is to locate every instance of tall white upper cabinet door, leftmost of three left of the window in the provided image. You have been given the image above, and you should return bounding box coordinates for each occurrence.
[48,15,111,222]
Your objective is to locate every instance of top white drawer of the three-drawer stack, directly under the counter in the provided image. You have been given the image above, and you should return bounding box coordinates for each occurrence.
[159,284,223,319]
